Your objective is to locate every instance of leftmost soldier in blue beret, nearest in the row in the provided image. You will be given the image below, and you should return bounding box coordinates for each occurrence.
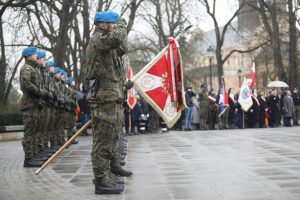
[20,46,43,167]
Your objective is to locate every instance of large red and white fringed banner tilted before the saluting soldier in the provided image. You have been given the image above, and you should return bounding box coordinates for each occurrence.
[132,38,186,128]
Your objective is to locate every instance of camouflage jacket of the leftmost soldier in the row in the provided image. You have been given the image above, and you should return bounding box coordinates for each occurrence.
[20,60,41,111]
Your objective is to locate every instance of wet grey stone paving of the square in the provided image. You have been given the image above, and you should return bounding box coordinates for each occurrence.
[0,127,300,200]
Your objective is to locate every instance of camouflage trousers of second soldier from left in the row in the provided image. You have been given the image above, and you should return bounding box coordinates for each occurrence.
[35,105,49,154]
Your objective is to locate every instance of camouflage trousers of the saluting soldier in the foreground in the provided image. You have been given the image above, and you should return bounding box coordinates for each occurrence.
[91,103,123,182]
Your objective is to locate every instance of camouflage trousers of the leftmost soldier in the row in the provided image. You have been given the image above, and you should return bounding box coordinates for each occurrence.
[22,108,38,159]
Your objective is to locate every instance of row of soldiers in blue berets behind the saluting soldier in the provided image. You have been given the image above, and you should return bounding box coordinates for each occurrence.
[20,46,77,167]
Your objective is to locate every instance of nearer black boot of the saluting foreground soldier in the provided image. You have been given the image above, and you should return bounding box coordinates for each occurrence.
[93,179,124,194]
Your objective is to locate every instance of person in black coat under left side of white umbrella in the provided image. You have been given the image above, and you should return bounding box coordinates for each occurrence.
[267,90,280,127]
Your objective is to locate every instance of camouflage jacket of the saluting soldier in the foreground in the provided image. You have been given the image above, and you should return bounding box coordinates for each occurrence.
[85,19,127,104]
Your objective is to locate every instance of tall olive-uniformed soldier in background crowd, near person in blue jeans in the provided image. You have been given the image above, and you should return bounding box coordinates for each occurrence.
[198,83,209,130]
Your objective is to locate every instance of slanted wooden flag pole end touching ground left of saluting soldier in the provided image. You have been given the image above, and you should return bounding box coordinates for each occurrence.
[35,120,92,175]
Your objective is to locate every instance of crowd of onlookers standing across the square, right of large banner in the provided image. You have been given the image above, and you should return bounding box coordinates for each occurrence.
[182,84,300,131]
